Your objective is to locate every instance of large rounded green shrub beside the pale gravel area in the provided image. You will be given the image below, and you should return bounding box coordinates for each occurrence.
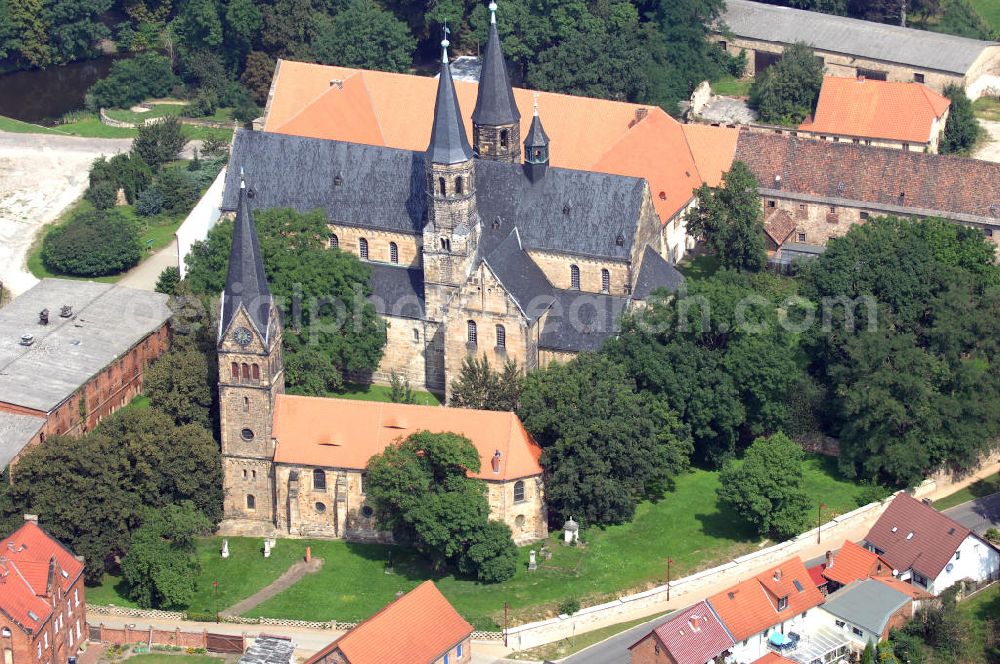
[42,210,142,277]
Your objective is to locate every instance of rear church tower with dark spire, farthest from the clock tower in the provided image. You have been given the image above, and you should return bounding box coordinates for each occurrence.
[472,2,521,164]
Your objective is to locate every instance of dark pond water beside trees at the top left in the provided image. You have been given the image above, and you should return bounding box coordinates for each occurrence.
[0,56,121,124]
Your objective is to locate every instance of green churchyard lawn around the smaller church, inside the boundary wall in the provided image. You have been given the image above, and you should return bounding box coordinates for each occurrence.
[88,457,860,628]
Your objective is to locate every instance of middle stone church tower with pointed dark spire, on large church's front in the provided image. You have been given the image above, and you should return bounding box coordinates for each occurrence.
[423,29,479,321]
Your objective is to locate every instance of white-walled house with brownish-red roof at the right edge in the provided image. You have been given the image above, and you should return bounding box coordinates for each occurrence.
[865,493,1000,595]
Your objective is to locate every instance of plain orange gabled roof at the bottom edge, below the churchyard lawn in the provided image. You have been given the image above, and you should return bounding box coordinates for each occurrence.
[305,581,472,664]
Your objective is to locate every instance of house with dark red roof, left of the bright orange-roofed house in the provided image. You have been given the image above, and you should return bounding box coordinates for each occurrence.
[629,601,733,664]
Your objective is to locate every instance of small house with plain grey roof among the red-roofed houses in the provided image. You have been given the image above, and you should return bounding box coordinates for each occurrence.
[820,579,913,649]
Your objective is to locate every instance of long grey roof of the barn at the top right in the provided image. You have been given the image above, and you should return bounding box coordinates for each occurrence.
[719,0,996,75]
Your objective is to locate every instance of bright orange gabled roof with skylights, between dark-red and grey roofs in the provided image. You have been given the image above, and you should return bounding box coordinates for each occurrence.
[708,558,823,641]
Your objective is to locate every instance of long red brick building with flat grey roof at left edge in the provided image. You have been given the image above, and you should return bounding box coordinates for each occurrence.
[0,279,171,469]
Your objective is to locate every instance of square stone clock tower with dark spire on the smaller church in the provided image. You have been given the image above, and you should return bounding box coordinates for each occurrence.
[218,177,285,535]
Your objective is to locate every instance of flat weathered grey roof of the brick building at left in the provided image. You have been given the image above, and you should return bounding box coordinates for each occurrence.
[0,279,172,413]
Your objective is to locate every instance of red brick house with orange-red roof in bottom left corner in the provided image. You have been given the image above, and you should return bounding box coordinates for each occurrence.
[0,515,87,664]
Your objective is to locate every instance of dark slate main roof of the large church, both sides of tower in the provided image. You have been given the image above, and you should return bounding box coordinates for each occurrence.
[222,130,645,260]
